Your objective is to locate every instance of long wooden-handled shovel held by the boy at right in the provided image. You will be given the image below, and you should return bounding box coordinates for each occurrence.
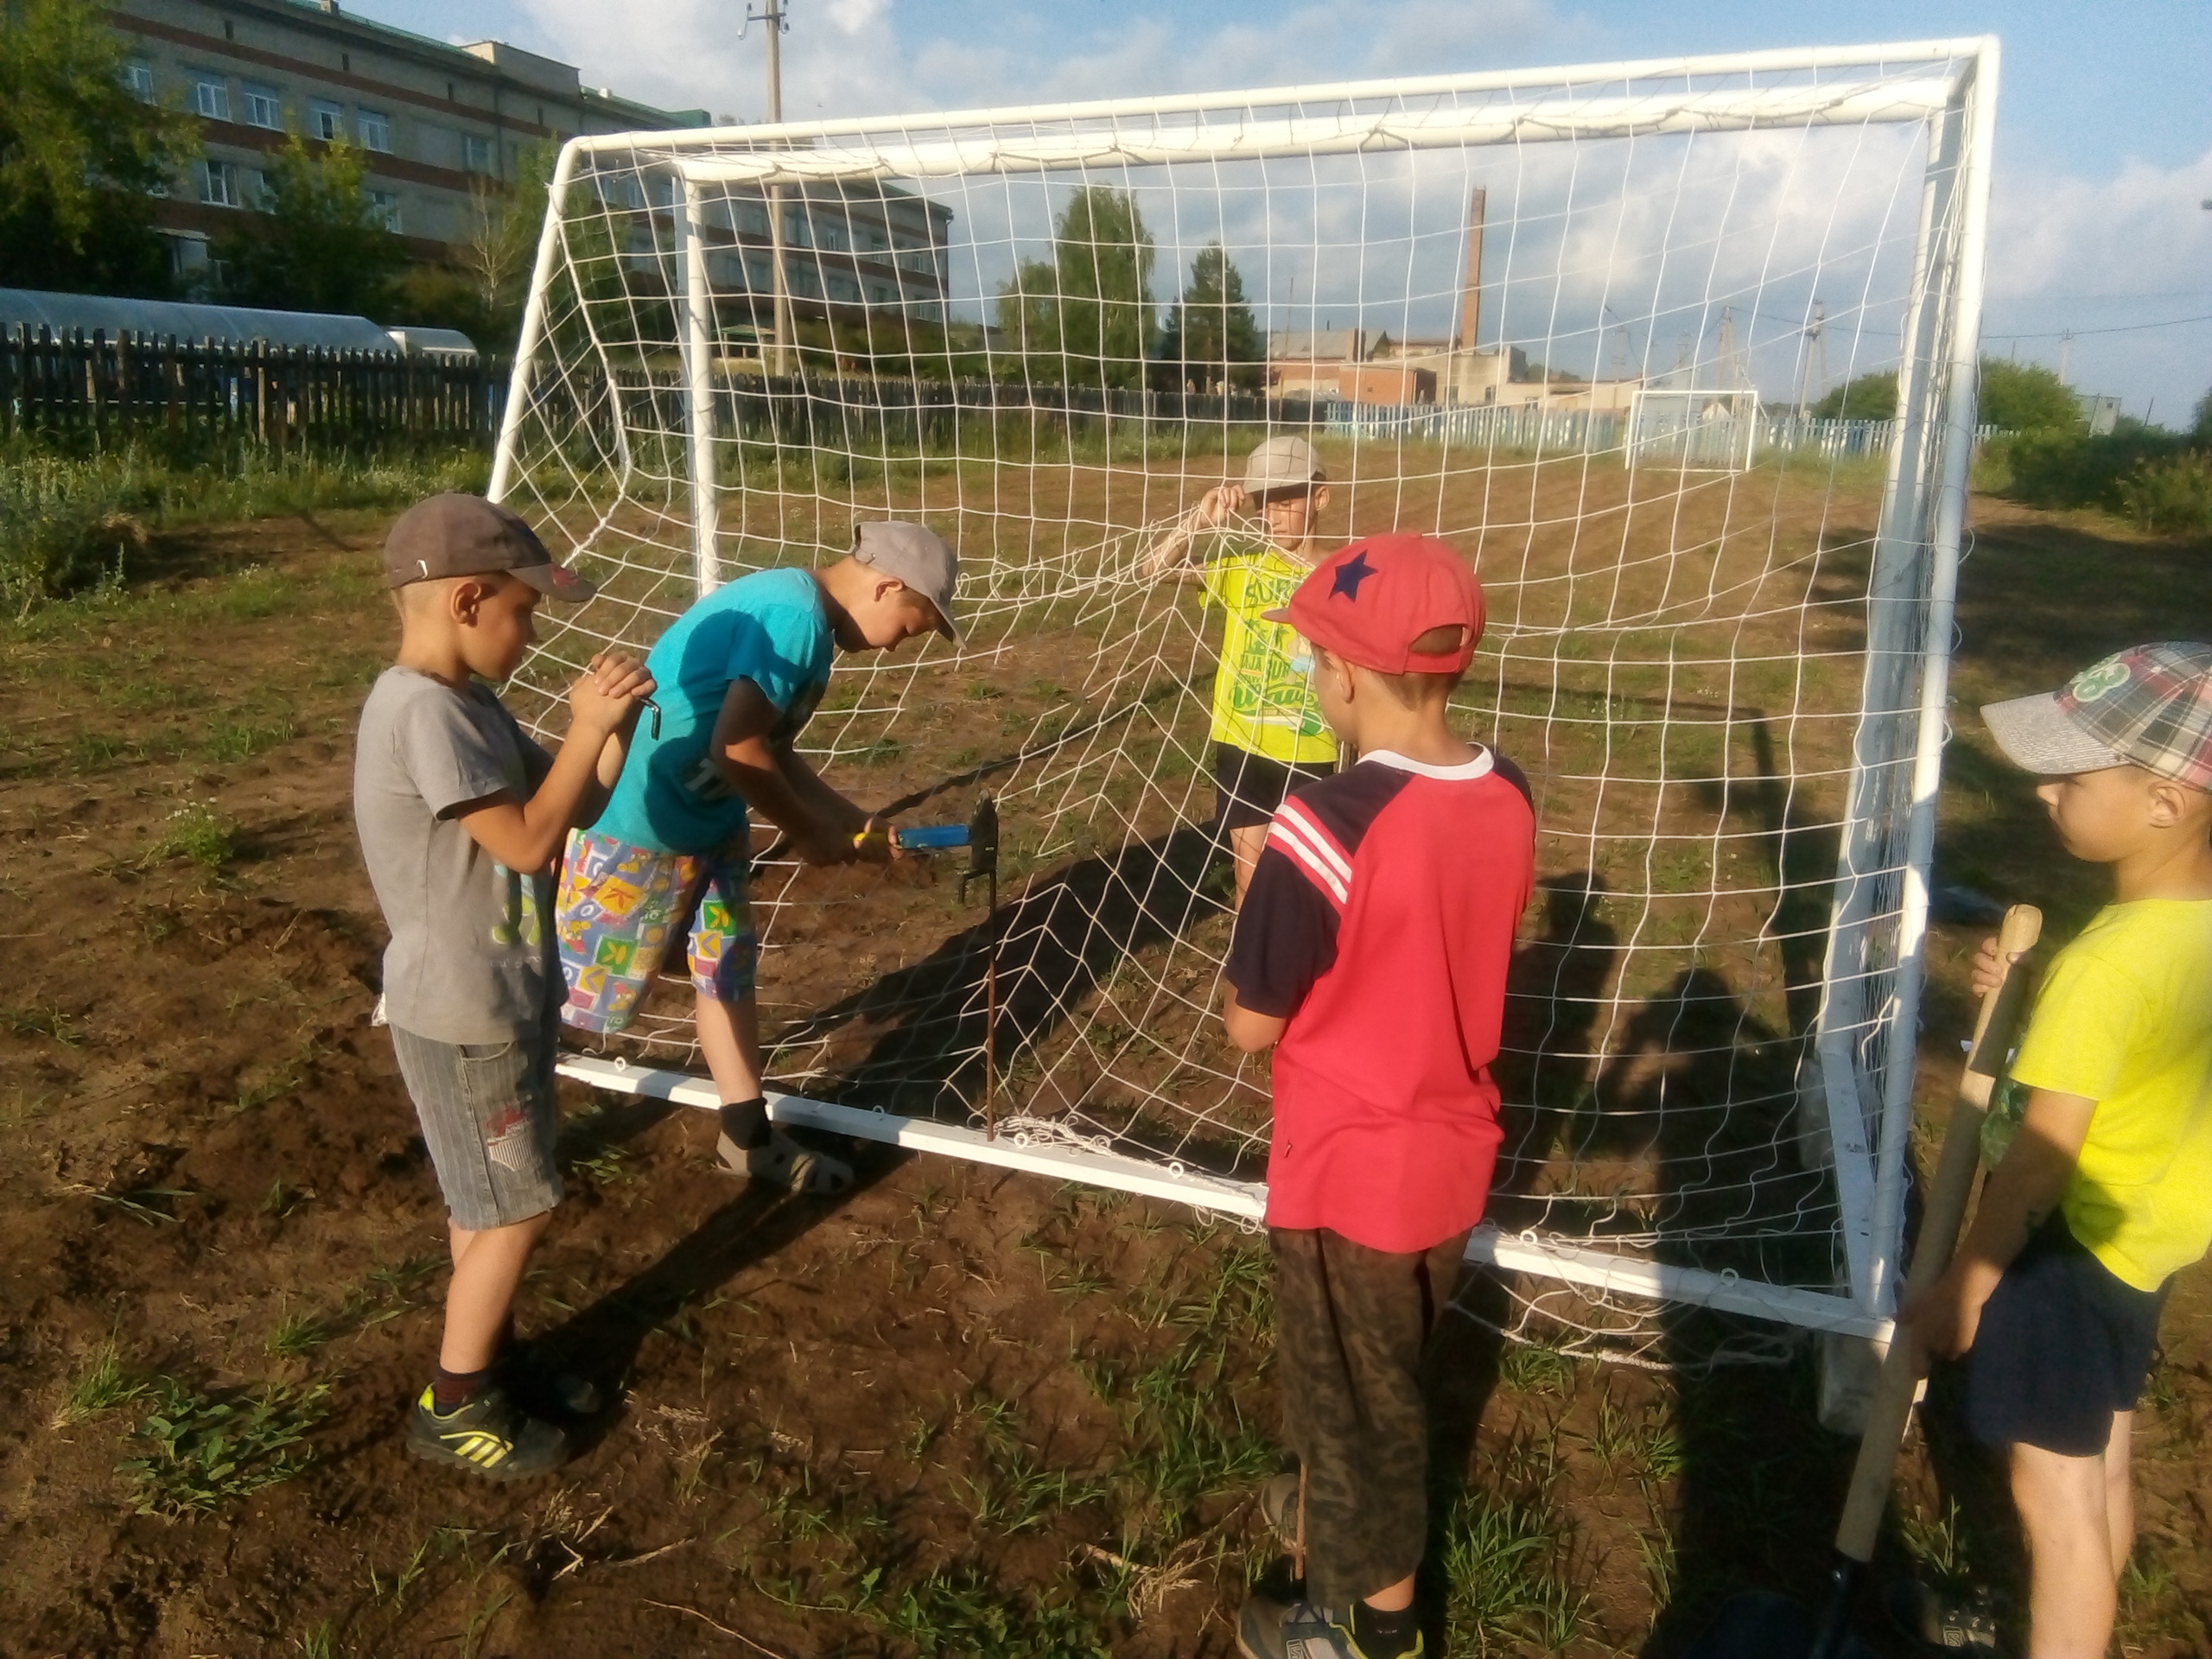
[1683,905,2044,1659]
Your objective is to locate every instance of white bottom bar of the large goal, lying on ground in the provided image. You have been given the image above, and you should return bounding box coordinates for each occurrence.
[560,1055,1889,1340]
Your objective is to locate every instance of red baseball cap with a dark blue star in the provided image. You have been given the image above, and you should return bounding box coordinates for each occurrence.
[1265,531,1482,675]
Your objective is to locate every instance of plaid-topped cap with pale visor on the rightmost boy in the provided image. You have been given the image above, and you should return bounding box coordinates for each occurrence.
[1982,639,2212,790]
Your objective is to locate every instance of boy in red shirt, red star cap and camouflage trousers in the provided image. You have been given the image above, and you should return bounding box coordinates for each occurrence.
[1224,536,1535,1659]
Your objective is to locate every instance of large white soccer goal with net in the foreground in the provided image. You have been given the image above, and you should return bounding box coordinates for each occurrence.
[493,40,1998,1356]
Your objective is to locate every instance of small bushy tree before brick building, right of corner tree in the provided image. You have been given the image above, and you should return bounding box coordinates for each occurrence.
[214,133,407,316]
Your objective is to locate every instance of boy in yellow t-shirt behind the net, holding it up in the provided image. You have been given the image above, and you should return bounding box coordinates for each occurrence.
[1144,435,1336,905]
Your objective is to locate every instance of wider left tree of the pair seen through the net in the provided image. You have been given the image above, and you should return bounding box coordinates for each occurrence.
[998,183,1154,387]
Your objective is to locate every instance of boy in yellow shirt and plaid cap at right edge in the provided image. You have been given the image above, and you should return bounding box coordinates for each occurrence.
[1903,644,2212,1659]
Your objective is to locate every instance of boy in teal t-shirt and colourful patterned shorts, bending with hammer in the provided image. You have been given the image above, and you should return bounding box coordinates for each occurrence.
[556,524,957,1192]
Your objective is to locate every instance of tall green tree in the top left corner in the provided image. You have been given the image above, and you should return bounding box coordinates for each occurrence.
[0,0,197,296]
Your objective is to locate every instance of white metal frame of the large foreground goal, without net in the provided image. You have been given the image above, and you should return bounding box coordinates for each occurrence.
[489,38,1998,1338]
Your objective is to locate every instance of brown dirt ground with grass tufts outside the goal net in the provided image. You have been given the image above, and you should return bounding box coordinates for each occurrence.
[0,502,2212,1659]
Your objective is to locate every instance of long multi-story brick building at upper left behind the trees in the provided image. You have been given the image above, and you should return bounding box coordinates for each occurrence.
[108,0,951,323]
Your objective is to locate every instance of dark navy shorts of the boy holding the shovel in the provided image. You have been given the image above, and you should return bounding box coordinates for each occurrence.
[1967,1214,2165,1458]
